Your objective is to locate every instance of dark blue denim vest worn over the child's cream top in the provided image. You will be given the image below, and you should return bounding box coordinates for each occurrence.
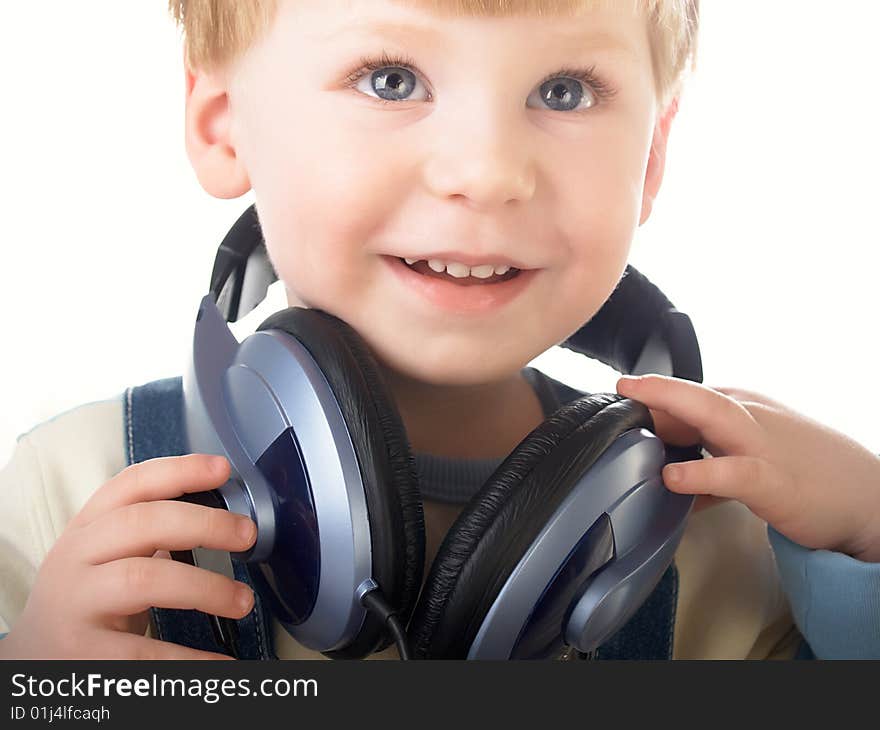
[124,376,678,659]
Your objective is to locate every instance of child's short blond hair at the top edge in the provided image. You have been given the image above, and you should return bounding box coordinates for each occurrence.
[168,0,700,109]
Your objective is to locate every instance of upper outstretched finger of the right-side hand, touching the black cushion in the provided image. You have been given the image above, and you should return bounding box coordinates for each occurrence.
[617,375,761,454]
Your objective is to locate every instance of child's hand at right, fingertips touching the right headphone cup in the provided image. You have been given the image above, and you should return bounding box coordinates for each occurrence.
[617,375,880,562]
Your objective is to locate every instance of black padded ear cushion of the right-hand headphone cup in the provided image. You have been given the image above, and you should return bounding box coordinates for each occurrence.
[409,393,654,659]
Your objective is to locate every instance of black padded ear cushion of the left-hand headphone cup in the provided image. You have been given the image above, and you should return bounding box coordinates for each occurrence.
[257,307,425,659]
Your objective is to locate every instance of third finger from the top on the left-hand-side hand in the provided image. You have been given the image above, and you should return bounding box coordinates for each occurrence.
[83,558,254,618]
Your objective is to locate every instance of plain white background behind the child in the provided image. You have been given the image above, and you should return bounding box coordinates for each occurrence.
[0,0,880,466]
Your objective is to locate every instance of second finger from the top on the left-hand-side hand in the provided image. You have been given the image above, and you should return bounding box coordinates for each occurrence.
[74,500,256,565]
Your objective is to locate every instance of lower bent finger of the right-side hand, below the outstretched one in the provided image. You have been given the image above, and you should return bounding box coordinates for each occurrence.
[662,456,797,522]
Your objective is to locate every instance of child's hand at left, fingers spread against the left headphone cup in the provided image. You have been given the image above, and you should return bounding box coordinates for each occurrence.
[0,454,256,659]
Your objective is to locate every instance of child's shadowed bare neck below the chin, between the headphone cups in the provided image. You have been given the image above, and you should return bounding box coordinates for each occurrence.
[382,366,544,459]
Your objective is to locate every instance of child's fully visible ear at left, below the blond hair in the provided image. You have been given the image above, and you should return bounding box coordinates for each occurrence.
[184,60,251,199]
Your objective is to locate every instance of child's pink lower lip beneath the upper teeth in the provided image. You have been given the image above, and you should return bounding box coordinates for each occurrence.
[382,255,540,313]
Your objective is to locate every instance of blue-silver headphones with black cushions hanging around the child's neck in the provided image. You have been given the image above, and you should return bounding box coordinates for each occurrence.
[173,206,702,659]
